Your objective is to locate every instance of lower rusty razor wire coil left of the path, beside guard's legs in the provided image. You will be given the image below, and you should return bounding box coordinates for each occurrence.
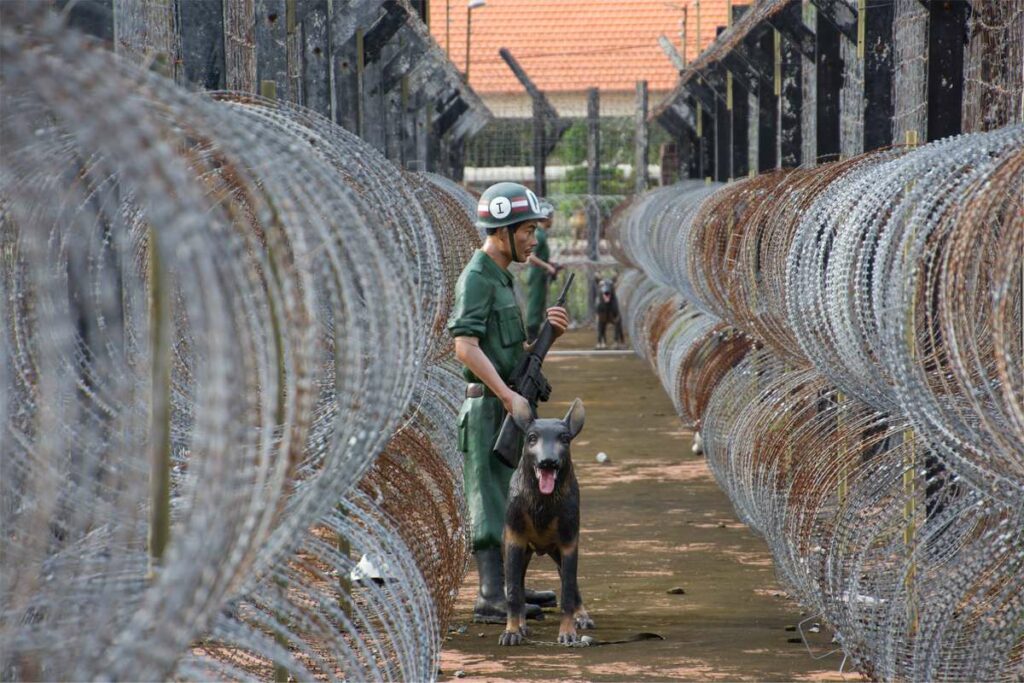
[178,361,469,680]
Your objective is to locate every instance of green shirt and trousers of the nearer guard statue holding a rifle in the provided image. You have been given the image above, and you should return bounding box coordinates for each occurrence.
[447,251,526,551]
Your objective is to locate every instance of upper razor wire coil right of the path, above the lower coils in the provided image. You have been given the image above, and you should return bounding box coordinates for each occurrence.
[618,126,1024,500]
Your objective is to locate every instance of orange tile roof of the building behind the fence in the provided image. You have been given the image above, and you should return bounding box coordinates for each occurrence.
[429,0,745,95]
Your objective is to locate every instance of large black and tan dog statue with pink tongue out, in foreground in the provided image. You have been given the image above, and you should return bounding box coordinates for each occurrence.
[498,398,594,645]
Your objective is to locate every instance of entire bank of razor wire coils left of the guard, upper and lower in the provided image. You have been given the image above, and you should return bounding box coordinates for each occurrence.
[0,12,478,680]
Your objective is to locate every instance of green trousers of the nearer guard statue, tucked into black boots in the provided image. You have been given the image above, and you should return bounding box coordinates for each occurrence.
[459,395,513,551]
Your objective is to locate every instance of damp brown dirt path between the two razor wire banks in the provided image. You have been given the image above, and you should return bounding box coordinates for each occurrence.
[441,331,860,681]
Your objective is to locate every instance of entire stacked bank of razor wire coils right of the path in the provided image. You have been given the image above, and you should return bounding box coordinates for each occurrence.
[613,126,1024,680]
